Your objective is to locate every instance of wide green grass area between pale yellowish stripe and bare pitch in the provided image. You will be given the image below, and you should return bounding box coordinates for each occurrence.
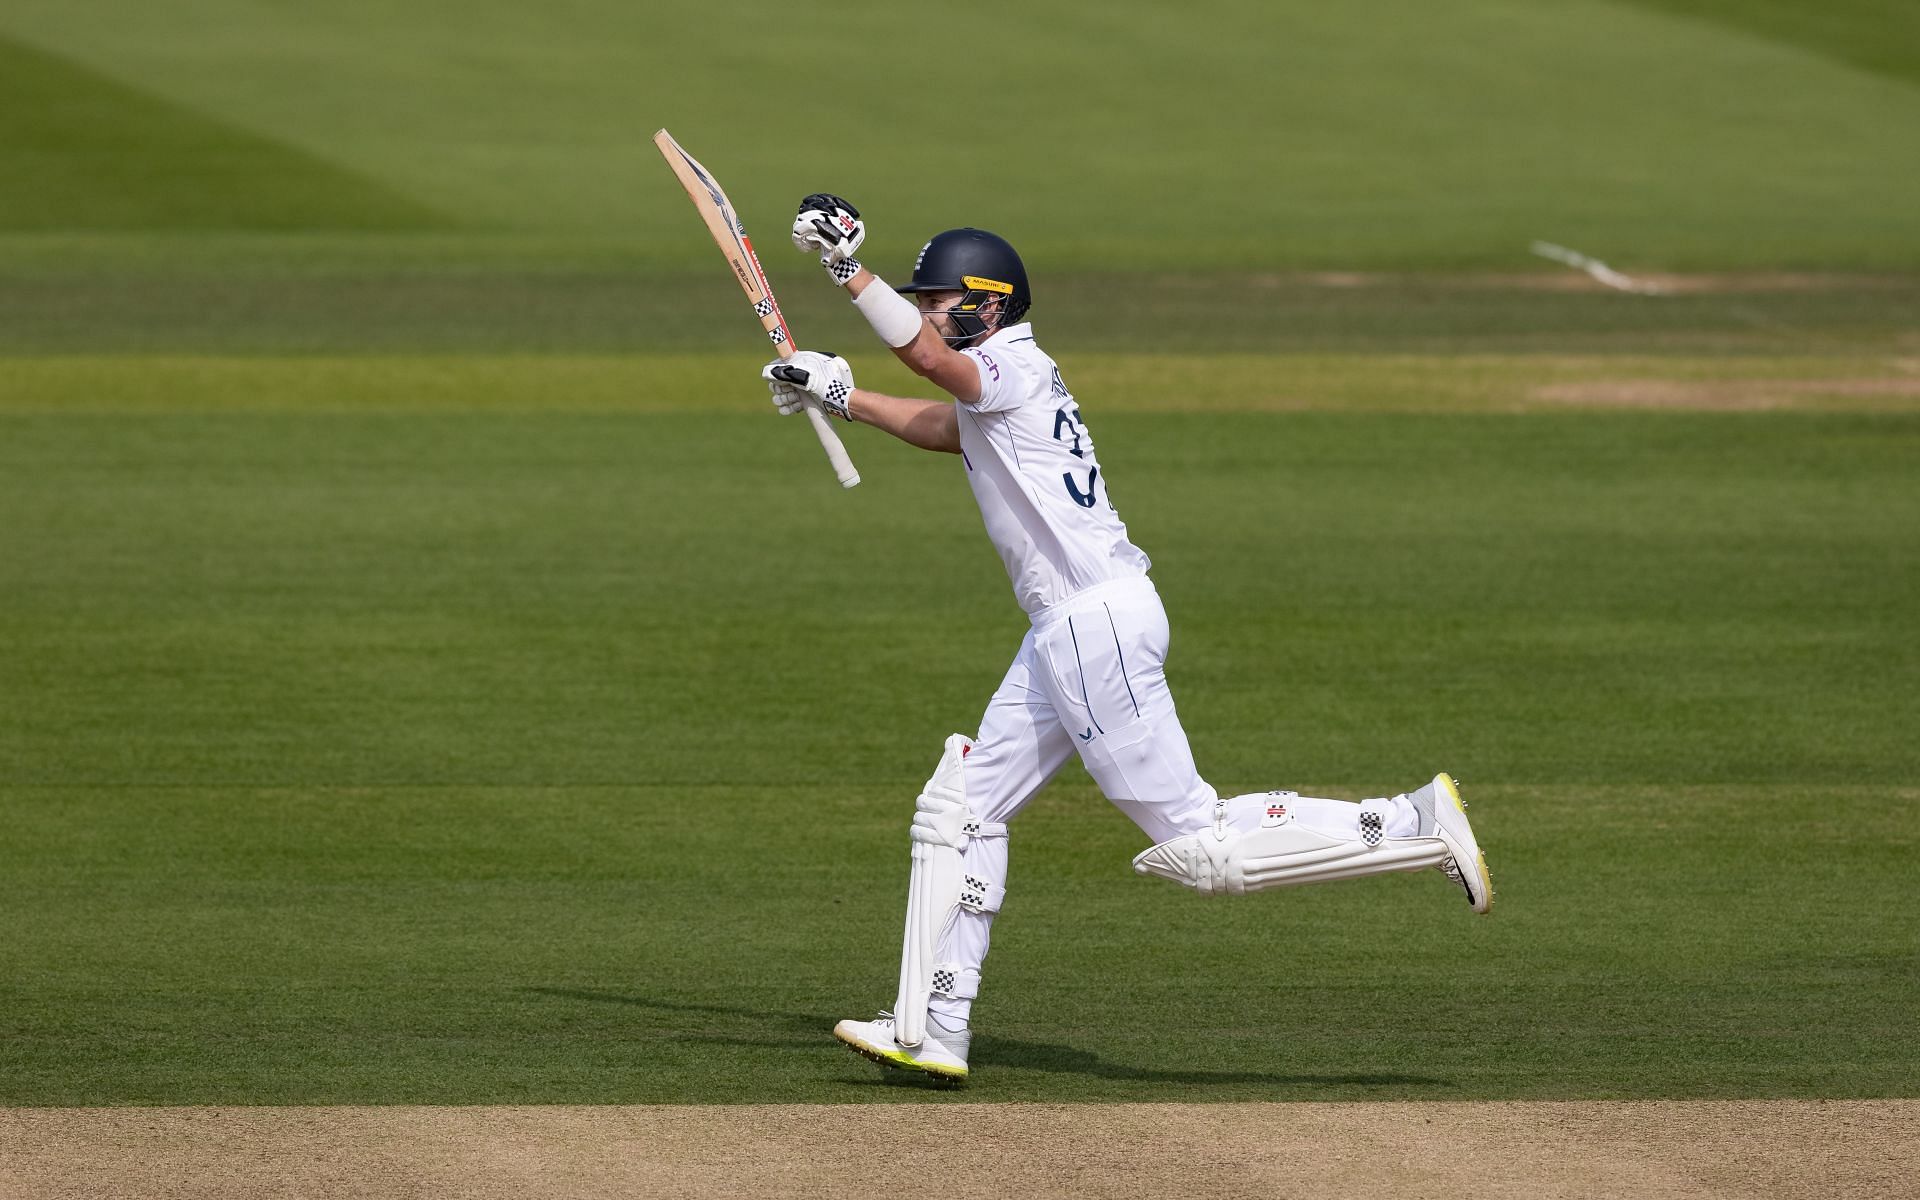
[0,361,1920,1104]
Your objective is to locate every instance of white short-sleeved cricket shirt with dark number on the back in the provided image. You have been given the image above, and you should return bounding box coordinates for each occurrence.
[954,323,1152,618]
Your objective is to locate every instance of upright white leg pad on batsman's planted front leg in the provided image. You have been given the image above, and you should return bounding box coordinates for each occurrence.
[893,733,1006,1046]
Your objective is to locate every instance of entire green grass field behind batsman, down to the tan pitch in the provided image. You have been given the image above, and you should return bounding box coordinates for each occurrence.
[0,0,1920,1106]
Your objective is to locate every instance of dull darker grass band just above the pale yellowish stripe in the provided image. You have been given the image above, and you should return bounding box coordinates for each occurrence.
[0,268,1920,353]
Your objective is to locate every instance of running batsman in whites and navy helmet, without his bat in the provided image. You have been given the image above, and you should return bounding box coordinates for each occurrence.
[762,194,1494,1083]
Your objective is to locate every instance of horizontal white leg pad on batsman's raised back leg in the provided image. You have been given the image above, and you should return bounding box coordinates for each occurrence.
[1133,804,1448,897]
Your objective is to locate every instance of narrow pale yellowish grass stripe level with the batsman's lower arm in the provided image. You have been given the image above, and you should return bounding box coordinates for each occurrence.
[0,351,1920,414]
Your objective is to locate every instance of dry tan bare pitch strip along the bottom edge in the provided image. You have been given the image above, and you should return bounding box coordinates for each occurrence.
[0,1100,1920,1200]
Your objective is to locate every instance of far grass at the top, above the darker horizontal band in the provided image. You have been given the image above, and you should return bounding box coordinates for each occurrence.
[0,0,1920,271]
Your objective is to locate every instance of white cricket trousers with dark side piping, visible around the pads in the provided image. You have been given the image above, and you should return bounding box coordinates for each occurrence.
[929,576,1415,1021]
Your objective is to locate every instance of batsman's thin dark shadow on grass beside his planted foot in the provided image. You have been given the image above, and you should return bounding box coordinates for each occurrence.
[520,987,1453,1087]
